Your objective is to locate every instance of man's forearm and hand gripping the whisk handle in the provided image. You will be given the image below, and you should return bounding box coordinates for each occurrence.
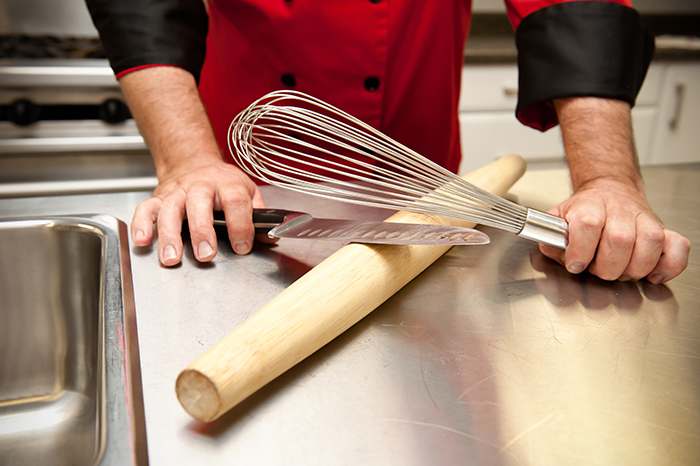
[540,97,690,283]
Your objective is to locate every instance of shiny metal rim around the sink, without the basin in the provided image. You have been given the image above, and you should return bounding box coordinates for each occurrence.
[0,214,148,465]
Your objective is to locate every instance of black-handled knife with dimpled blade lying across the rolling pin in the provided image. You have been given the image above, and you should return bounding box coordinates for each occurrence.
[208,209,490,246]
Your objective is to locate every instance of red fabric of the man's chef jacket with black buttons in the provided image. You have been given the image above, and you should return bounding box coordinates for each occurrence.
[101,0,631,171]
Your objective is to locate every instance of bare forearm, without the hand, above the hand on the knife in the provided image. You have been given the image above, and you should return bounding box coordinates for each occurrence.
[120,66,222,180]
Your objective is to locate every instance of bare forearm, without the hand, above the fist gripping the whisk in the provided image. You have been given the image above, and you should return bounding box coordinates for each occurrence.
[554,97,643,196]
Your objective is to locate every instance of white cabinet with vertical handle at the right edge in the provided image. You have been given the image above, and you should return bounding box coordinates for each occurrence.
[640,62,700,164]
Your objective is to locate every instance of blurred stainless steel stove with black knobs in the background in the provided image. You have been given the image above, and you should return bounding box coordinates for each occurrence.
[0,33,156,197]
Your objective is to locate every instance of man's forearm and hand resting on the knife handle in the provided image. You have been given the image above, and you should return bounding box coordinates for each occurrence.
[119,66,272,266]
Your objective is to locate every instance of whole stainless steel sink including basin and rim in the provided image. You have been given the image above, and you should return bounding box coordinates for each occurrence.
[0,215,147,466]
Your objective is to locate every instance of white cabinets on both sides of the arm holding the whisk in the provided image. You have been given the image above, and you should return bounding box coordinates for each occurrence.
[459,62,700,174]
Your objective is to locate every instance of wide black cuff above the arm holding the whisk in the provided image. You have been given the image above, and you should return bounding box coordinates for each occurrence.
[515,1,654,131]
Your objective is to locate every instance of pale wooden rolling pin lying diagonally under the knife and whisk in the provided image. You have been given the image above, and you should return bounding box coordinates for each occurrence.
[175,155,525,421]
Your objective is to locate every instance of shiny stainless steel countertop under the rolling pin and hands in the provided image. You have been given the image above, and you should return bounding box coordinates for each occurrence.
[0,164,700,465]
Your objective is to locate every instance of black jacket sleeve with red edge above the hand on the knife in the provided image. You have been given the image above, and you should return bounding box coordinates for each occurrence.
[86,0,208,80]
